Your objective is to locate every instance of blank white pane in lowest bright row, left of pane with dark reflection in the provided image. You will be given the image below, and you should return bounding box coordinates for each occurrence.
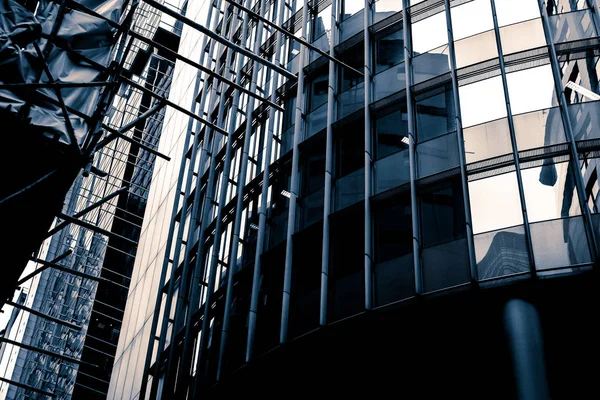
[469,172,523,234]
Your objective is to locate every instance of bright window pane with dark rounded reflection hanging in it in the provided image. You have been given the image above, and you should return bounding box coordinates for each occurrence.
[521,159,580,222]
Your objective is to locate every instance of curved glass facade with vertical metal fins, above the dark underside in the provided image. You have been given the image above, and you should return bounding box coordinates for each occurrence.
[108,0,600,399]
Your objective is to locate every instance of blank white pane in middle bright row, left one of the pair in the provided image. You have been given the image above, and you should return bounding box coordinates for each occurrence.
[458,76,506,127]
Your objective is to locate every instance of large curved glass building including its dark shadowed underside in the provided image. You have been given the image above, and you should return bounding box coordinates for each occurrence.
[108,0,600,399]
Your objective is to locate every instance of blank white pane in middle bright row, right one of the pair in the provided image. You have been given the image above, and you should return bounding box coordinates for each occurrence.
[506,65,558,114]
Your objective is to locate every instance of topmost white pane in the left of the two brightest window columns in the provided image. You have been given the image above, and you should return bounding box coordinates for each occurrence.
[451,0,494,40]
